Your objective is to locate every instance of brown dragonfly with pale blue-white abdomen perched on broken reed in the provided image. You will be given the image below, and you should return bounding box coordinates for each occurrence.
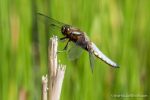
[38,13,119,72]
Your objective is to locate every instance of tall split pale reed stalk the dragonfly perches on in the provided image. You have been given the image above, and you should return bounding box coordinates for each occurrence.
[48,36,66,100]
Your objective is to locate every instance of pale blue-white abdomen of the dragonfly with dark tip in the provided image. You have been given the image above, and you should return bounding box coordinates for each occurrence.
[92,43,118,67]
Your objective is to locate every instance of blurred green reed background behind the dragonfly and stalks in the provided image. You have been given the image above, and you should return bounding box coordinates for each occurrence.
[0,0,150,100]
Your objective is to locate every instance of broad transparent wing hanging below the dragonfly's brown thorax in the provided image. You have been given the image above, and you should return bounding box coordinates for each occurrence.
[67,42,83,60]
